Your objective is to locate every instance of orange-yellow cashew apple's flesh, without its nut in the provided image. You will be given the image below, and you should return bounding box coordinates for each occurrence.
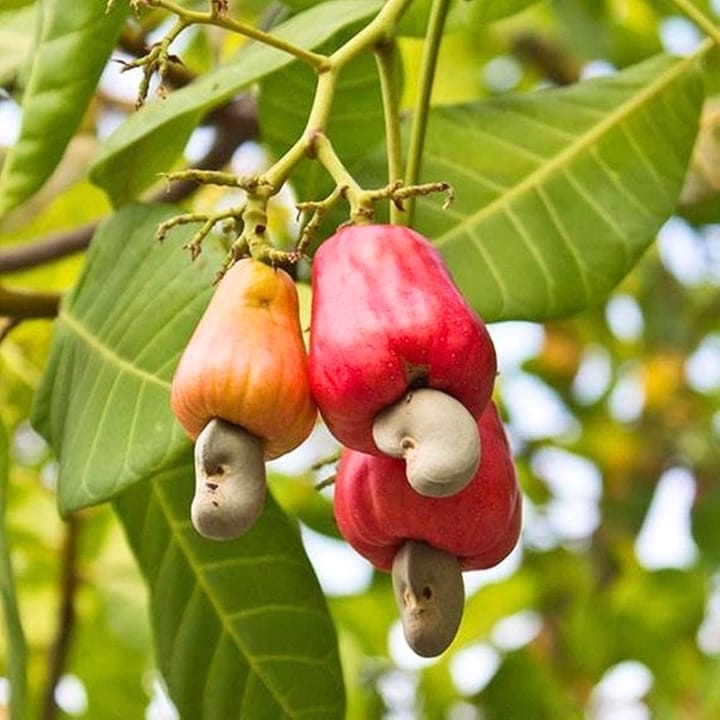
[171,259,317,460]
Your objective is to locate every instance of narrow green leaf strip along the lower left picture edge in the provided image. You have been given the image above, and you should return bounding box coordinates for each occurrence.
[0,423,27,720]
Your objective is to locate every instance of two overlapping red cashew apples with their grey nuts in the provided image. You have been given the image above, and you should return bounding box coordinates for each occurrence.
[309,225,521,656]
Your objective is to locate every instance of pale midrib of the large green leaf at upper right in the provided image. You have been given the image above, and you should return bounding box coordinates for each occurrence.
[435,40,714,246]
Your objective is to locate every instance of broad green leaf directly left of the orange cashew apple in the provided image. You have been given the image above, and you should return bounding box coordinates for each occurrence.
[28,205,221,515]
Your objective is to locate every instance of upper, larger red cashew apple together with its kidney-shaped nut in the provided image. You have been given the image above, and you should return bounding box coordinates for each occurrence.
[309,225,497,496]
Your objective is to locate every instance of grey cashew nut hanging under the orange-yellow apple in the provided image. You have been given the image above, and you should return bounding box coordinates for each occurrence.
[190,418,267,540]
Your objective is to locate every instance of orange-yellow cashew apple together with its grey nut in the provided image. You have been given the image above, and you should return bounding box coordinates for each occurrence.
[171,259,317,539]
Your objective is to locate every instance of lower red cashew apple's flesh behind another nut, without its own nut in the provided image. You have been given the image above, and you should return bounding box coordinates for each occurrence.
[334,402,522,572]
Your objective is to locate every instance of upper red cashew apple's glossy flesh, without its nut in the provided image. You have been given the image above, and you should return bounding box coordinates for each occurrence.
[308,225,497,454]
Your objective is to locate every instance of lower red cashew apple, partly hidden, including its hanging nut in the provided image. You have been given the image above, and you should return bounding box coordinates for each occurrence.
[334,402,522,657]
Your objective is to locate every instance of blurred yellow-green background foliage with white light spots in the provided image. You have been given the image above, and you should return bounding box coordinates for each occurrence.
[0,0,720,720]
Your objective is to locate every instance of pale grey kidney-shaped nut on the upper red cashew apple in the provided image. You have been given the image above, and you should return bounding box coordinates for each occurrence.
[373,388,480,497]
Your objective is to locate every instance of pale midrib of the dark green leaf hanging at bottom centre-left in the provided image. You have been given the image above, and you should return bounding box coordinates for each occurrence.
[151,476,323,717]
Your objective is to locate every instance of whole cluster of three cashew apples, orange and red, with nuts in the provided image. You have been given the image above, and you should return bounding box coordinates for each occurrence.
[172,225,521,656]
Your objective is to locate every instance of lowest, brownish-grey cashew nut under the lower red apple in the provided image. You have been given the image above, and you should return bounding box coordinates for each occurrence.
[392,540,465,657]
